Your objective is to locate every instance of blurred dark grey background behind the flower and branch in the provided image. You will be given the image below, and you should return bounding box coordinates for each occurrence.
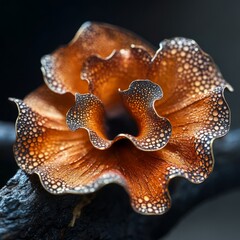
[0,0,240,240]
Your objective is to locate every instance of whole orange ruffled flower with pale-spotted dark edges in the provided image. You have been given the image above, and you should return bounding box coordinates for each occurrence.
[13,23,232,214]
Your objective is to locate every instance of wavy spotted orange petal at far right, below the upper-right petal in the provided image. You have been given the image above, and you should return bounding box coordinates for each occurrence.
[164,87,230,183]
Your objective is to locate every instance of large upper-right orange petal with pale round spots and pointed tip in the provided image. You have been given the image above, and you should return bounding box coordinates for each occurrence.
[149,38,232,115]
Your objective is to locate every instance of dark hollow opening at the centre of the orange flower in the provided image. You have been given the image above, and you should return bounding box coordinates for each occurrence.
[106,107,139,140]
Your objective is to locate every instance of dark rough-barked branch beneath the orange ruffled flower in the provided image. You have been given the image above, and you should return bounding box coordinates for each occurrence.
[0,123,240,240]
